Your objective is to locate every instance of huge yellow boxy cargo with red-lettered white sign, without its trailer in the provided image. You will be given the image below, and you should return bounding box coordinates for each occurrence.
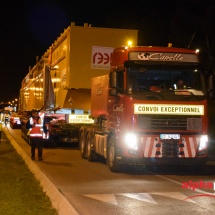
[20,23,138,114]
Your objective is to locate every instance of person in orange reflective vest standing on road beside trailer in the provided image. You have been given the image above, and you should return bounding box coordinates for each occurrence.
[26,111,43,161]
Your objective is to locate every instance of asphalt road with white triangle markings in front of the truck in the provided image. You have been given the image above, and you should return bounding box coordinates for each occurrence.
[3,127,215,215]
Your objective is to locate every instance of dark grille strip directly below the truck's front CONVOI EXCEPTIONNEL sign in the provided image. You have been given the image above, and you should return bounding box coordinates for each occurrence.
[138,115,202,130]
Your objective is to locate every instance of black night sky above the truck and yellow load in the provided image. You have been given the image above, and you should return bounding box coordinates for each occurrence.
[0,0,215,102]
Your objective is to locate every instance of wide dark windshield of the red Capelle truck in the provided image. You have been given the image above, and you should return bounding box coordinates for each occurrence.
[127,67,203,94]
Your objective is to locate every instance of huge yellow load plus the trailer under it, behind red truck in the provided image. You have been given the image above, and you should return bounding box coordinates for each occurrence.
[19,22,138,146]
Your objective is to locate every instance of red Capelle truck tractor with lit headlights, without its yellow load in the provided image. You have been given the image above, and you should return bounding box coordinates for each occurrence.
[79,46,208,172]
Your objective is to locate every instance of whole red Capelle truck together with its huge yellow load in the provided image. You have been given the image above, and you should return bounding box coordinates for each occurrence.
[19,23,208,172]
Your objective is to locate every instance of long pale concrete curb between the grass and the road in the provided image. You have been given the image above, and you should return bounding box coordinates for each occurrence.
[2,128,78,215]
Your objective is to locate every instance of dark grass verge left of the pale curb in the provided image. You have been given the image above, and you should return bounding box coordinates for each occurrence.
[0,132,58,215]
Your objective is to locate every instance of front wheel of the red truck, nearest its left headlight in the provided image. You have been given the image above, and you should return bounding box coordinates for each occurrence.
[107,136,120,172]
